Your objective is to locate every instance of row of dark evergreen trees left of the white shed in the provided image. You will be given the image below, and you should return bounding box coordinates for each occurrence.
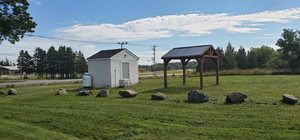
[17,46,87,79]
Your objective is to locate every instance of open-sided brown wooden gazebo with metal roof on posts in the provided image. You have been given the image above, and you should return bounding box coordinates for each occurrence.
[161,45,219,89]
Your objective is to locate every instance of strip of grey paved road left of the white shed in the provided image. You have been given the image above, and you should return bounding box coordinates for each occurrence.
[0,79,82,88]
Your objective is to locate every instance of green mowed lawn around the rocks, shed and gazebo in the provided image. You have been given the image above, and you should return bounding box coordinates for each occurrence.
[0,75,300,140]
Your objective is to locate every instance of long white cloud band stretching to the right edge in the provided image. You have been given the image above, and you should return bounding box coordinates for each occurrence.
[57,8,300,41]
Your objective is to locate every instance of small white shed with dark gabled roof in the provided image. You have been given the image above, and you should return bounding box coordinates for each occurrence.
[87,48,139,88]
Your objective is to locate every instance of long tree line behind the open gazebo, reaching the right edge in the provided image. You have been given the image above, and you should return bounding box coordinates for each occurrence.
[139,29,300,72]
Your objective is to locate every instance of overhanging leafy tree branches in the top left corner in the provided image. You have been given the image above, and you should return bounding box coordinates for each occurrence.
[0,0,36,44]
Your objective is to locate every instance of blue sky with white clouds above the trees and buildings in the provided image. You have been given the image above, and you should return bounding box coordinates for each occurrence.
[0,0,300,64]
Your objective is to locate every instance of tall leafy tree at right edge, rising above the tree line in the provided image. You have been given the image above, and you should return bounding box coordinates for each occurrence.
[276,29,300,71]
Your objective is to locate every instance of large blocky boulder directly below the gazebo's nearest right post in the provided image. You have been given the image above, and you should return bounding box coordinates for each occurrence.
[188,90,208,103]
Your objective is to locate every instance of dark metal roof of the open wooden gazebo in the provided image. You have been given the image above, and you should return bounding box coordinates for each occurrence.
[161,45,213,59]
